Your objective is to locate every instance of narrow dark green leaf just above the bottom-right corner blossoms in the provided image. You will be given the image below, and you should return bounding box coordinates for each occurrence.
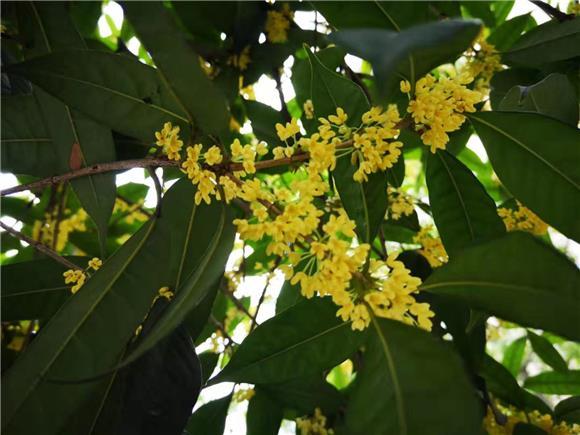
[479,354,551,414]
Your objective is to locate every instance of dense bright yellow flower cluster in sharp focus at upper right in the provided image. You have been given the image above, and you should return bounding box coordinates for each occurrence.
[401,74,482,153]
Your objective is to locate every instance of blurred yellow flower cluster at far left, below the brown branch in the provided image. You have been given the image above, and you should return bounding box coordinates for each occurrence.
[32,208,88,252]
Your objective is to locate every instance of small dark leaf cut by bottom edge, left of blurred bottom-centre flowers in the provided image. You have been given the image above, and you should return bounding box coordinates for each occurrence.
[246,387,283,435]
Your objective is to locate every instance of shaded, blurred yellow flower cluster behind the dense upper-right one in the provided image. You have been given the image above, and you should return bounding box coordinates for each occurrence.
[463,33,503,94]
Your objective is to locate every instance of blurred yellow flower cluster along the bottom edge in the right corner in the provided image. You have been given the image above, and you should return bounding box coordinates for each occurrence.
[483,404,580,435]
